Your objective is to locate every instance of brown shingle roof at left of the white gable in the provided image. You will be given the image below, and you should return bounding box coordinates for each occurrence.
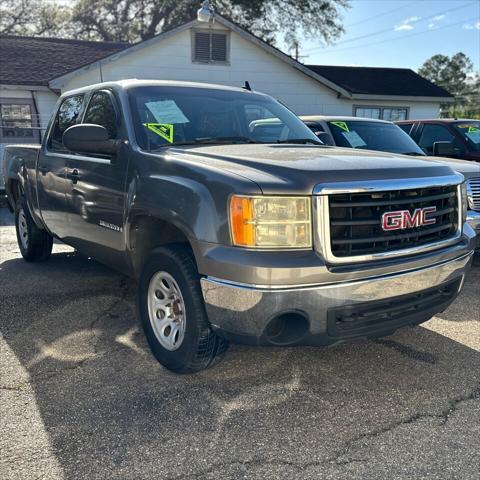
[0,35,129,86]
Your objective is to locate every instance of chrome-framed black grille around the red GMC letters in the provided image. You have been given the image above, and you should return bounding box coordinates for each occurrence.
[314,174,462,264]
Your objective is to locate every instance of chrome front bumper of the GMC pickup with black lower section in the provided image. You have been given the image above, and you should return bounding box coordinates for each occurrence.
[201,252,473,345]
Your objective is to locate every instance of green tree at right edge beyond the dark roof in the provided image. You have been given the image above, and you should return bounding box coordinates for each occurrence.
[418,52,480,117]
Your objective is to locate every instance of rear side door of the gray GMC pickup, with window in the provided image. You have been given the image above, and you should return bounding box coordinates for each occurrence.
[37,95,83,238]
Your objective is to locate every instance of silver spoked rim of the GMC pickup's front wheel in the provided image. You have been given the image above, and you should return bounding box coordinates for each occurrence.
[148,272,186,351]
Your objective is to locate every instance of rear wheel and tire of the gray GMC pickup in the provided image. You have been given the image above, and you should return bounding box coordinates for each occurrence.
[15,197,53,262]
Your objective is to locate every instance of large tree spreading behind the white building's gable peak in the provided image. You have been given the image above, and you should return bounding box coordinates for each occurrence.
[0,0,349,47]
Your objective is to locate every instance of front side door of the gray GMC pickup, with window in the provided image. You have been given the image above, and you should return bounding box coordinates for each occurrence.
[67,90,128,269]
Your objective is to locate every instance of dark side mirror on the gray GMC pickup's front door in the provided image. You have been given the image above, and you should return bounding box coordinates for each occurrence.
[62,123,118,155]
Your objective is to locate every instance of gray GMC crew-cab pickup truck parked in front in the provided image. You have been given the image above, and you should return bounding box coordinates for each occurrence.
[4,80,475,373]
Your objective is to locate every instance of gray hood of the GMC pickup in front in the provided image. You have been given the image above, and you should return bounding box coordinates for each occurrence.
[169,144,458,194]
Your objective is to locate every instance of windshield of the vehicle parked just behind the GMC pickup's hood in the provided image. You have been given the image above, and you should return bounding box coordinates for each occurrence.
[328,120,425,155]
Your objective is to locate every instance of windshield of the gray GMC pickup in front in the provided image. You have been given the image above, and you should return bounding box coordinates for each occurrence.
[129,86,321,151]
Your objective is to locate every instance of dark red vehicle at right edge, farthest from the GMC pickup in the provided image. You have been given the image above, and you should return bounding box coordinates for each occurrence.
[396,119,480,162]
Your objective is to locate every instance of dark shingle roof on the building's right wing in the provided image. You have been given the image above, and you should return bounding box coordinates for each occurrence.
[305,65,453,98]
